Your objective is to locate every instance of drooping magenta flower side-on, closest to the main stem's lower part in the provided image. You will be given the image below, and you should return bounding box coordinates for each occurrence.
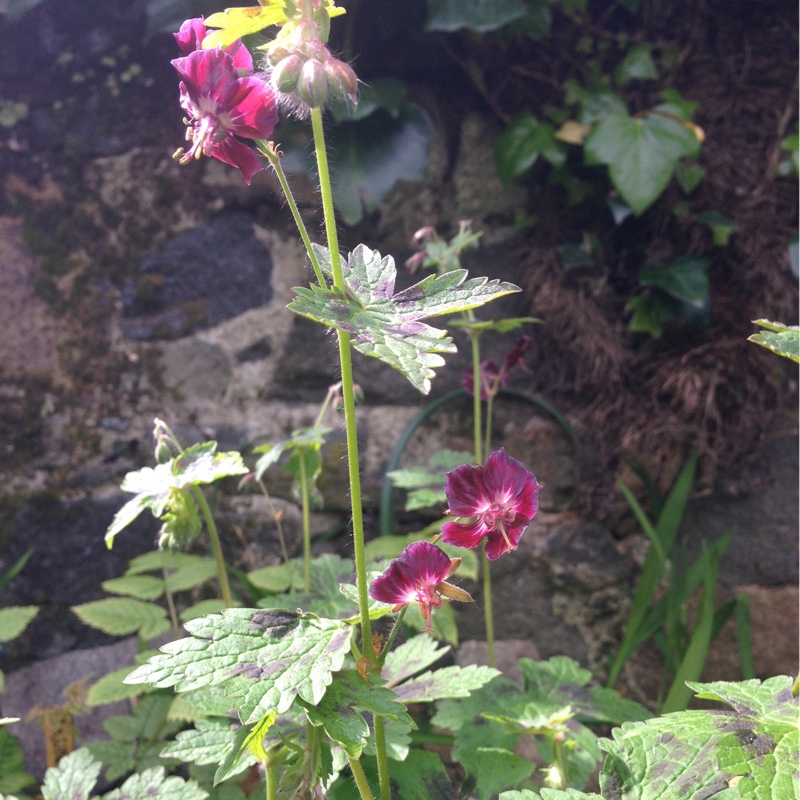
[369,541,472,631]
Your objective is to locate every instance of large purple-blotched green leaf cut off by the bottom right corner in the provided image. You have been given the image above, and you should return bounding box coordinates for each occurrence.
[600,676,800,800]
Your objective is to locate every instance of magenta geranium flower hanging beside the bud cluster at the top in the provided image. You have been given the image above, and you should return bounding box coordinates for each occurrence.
[172,49,278,184]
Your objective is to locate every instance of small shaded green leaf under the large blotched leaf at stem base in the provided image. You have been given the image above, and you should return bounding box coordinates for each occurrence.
[301,670,417,758]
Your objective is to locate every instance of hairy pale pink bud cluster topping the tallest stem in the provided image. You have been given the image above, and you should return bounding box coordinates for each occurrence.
[265,4,358,108]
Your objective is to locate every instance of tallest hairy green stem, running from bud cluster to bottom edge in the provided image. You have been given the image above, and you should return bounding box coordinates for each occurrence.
[311,108,391,800]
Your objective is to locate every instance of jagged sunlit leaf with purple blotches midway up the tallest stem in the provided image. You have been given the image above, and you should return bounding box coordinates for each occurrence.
[289,245,519,394]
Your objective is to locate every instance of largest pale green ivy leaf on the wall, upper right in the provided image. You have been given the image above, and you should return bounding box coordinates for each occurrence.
[584,111,700,215]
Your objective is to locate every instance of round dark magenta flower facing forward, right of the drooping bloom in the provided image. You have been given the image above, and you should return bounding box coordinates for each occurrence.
[442,448,542,561]
